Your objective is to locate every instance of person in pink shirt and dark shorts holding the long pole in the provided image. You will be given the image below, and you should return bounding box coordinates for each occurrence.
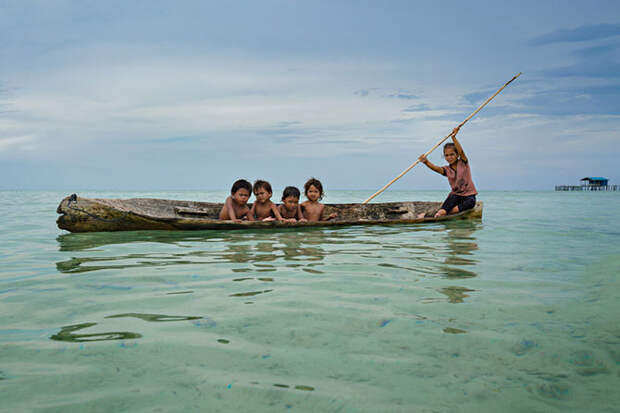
[418,128,478,218]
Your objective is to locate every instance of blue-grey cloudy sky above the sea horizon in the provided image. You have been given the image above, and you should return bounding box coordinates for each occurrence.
[0,0,620,191]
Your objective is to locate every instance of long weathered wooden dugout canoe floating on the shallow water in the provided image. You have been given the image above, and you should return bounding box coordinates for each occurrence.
[56,194,482,232]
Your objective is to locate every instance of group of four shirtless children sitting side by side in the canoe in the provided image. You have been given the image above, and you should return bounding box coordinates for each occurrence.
[220,178,336,222]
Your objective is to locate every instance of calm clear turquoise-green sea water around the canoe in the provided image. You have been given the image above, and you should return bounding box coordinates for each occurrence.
[0,191,620,412]
